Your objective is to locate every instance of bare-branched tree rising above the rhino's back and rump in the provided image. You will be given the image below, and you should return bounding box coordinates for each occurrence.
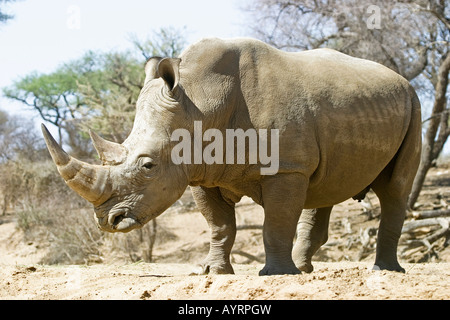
[244,0,450,208]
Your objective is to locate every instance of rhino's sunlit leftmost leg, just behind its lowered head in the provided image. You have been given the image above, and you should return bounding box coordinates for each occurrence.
[191,187,236,274]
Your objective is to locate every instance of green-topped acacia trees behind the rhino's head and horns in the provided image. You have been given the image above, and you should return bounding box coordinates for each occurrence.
[3,29,184,158]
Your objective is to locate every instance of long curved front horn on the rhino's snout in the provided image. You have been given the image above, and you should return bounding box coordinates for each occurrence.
[41,124,111,206]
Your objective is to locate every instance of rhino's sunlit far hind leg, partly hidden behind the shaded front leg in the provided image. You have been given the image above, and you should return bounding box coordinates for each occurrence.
[292,207,333,273]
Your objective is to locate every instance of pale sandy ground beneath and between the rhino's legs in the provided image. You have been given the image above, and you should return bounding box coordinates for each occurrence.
[0,169,450,300]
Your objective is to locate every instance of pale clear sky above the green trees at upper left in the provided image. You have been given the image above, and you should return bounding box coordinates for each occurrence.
[0,0,246,114]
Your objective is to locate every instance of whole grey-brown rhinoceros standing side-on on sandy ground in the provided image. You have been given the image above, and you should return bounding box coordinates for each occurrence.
[43,38,421,275]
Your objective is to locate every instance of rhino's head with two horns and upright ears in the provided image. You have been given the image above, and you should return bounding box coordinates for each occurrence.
[42,58,195,232]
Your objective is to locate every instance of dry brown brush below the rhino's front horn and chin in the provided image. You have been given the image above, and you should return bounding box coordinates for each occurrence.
[0,160,176,264]
